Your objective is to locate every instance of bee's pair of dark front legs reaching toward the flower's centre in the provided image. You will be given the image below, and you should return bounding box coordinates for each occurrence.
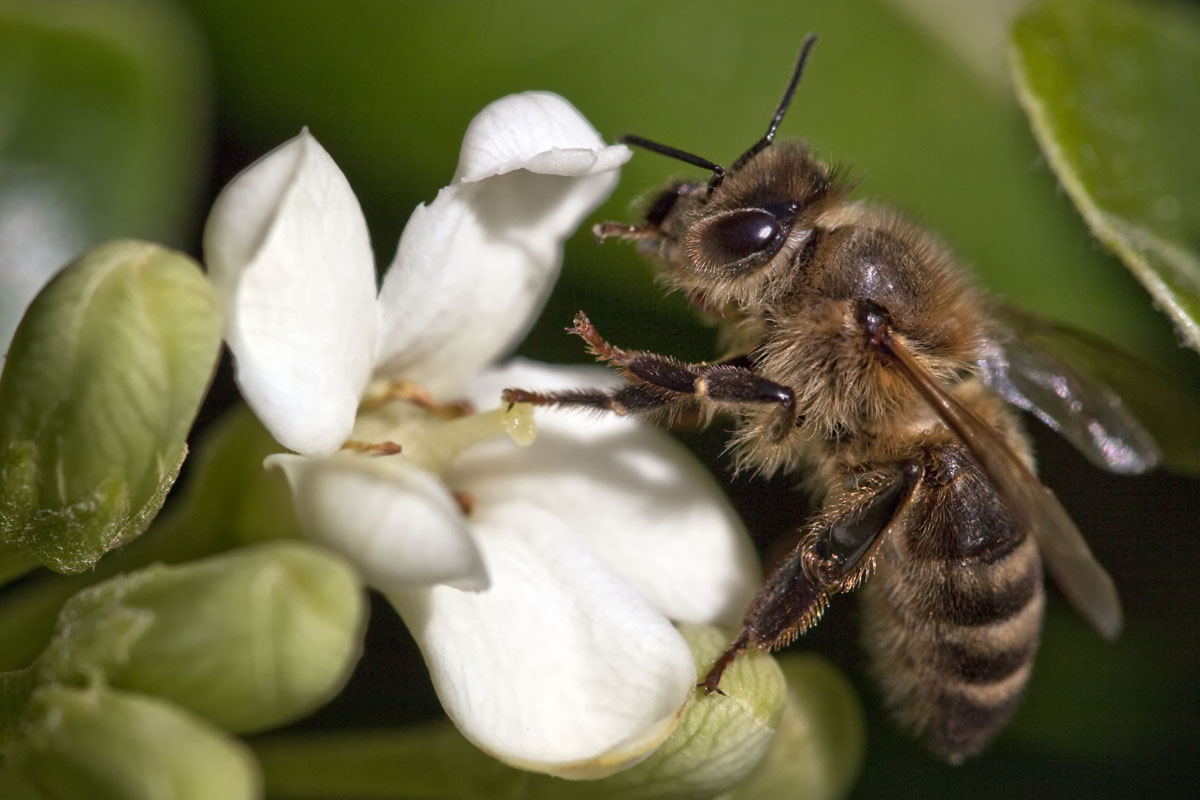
[503,312,796,439]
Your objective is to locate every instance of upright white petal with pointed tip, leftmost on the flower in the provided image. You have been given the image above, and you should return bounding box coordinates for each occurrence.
[204,131,376,453]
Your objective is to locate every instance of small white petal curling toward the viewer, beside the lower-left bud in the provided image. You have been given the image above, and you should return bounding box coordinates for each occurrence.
[266,453,487,591]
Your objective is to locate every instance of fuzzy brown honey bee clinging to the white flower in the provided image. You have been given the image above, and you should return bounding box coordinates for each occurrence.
[504,36,1157,763]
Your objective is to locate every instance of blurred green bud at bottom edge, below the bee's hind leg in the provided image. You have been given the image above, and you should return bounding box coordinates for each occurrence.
[727,654,866,800]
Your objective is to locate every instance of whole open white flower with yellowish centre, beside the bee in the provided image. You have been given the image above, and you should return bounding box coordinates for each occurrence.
[204,92,757,777]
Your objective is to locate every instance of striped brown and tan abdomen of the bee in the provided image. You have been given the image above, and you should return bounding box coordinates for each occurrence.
[864,446,1044,763]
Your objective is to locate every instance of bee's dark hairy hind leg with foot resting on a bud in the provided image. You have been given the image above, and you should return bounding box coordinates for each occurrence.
[700,462,924,692]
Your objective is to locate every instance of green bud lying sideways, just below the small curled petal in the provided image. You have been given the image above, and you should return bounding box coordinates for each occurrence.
[37,542,366,732]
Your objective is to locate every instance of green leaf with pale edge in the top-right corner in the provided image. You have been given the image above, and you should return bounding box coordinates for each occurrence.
[1013,0,1200,349]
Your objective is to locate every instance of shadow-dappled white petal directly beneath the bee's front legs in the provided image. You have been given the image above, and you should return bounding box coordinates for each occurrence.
[445,360,761,625]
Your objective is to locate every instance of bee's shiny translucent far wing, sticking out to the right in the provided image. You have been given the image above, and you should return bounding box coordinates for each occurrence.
[978,312,1159,475]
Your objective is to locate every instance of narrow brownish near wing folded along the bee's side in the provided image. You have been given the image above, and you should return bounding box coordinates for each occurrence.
[883,337,1121,639]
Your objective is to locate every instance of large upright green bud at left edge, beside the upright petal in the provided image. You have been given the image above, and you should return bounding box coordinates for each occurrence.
[0,241,221,573]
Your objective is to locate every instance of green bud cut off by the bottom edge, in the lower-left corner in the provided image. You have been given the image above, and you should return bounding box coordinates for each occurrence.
[11,686,259,800]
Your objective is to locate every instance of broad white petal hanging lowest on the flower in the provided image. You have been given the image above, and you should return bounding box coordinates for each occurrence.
[389,503,696,777]
